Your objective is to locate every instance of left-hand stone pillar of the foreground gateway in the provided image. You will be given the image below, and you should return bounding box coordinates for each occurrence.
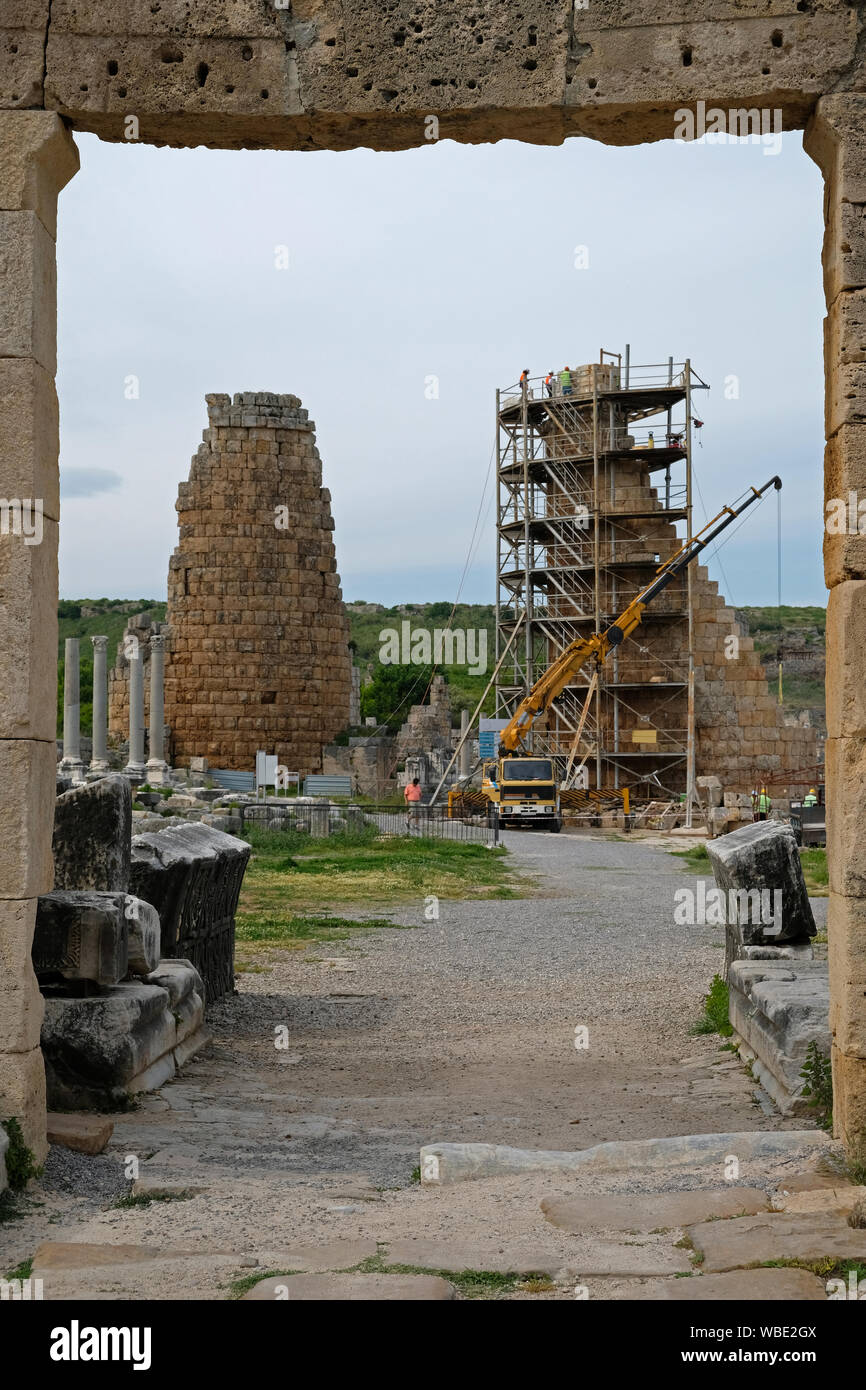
[0,111,78,1162]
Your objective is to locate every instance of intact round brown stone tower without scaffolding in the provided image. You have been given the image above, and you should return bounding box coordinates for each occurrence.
[165,392,352,773]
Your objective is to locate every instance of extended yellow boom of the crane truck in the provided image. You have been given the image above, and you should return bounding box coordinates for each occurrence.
[499,477,781,756]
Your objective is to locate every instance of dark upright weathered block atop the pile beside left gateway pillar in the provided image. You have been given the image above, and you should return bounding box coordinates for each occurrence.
[53,773,132,892]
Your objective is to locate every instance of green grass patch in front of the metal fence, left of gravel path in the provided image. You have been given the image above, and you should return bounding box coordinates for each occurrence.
[238,826,517,917]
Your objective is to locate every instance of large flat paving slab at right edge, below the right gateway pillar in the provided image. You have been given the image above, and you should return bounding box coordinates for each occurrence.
[688,1212,866,1273]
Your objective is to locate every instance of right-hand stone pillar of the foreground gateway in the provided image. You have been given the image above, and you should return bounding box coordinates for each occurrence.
[805,93,866,1152]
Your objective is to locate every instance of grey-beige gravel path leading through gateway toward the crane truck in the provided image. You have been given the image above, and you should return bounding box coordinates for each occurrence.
[0,834,828,1297]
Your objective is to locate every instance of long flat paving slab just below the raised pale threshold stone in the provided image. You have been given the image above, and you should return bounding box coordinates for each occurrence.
[541,1187,767,1234]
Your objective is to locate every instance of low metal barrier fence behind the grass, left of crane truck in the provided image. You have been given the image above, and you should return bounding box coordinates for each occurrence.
[239,799,499,845]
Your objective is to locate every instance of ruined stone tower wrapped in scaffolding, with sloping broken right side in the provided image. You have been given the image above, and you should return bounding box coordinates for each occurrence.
[496,353,817,796]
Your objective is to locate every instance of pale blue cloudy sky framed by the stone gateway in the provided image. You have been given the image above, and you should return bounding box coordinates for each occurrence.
[58,133,826,606]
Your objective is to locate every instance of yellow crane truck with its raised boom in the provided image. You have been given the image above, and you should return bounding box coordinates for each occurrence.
[469,477,781,830]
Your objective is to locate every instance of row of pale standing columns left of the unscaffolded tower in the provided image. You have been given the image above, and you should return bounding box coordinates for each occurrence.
[60,632,168,784]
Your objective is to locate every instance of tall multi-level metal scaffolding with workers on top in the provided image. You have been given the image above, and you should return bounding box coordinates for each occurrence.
[496,348,706,806]
